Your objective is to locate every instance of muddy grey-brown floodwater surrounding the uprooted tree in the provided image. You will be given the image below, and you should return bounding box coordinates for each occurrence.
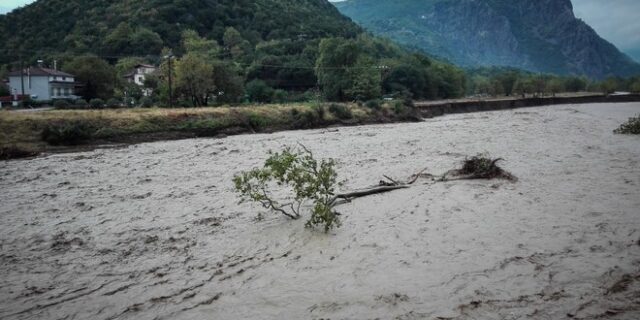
[0,103,640,320]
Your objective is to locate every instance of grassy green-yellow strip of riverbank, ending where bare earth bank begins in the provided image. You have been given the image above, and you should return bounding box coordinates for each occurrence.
[0,101,417,152]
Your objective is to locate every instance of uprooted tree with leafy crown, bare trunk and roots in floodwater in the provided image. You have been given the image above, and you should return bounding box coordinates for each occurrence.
[233,145,516,232]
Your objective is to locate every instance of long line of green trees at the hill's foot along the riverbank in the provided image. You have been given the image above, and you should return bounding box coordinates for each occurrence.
[0,26,640,107]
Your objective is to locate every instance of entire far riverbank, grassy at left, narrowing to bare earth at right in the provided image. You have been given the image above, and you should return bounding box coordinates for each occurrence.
[0,94,640,160]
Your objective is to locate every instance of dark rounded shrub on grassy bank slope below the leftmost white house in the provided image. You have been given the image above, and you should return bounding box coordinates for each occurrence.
[40,121,94,145]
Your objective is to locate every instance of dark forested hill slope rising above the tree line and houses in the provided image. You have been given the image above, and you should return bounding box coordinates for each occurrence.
[0,0,361,64]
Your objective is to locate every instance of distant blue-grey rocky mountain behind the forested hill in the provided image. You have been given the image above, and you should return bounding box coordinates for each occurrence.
[335,0,640,78]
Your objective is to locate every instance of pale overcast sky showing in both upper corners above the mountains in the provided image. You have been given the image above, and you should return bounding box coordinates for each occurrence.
[0,0,640,61]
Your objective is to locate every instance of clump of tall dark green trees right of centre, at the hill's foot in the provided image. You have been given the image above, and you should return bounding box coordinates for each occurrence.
[316,35,466,101]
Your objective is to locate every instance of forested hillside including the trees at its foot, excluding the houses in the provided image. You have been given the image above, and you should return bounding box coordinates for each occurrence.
[0,0,472,105]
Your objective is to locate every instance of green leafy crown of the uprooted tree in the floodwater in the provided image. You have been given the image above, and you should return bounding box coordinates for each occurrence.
[233,147,340,232]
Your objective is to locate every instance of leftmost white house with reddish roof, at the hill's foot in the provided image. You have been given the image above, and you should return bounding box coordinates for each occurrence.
[9,67,78,101]
